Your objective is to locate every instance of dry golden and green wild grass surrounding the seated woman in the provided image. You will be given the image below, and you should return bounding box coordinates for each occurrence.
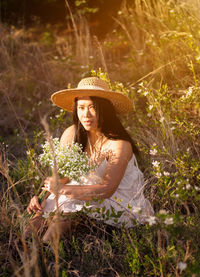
[0,0,200,277]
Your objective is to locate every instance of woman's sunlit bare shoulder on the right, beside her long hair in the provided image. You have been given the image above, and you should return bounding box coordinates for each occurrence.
[107,140,133,160]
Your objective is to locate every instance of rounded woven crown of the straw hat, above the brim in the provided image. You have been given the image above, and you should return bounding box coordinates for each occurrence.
[77,77,110,91]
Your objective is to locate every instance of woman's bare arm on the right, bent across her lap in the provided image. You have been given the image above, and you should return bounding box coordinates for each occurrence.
[43,140,133,200]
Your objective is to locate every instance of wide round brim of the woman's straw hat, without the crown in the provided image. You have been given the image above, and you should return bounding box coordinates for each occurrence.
[51,89,133,114]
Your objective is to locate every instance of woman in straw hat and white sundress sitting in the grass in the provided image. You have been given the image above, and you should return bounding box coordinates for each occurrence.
[27,77,153,242]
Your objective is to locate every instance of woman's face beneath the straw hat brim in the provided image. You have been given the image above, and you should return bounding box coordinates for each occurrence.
[77,97,98,131]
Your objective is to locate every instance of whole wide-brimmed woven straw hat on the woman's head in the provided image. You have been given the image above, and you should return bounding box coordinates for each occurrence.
[51,77,132,114]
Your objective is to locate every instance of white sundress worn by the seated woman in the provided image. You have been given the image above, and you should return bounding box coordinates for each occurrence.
[43,151,154,228]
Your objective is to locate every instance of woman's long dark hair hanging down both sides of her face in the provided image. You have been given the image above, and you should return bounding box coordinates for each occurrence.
[73,96,139,156]
